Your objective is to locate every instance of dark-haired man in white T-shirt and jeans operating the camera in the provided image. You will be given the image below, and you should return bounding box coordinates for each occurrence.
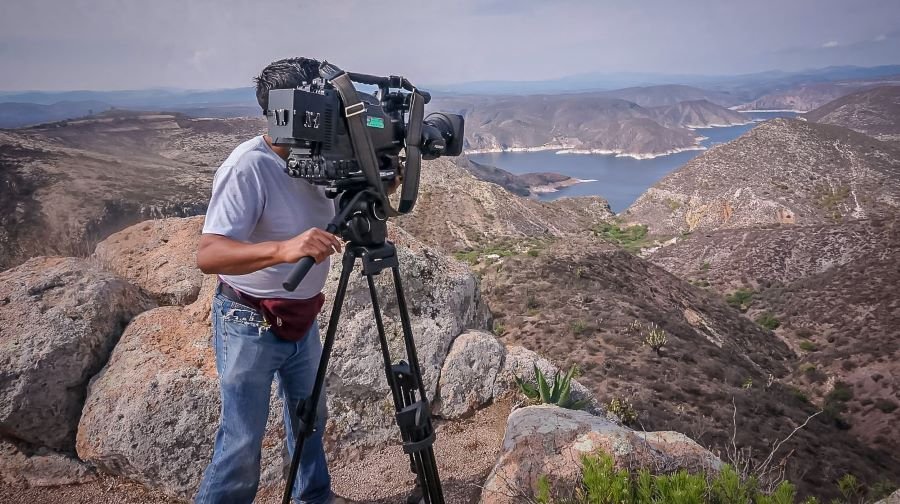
[196,58,346,504]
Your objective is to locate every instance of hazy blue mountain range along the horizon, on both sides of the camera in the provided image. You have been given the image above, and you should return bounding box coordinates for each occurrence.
[0,65,900,128]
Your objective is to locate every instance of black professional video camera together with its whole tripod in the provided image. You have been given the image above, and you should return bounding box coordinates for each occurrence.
[266,60,463,504]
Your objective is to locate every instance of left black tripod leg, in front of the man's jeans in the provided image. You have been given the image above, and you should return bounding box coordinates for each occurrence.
[281,254,356,504]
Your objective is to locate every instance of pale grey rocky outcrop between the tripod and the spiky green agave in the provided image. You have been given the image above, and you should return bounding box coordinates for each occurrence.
[434,331,595,419]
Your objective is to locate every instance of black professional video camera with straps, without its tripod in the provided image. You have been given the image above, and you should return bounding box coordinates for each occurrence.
[266,62,464,213]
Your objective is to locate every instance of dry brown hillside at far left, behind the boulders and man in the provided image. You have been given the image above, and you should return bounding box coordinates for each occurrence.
[0,112,264,269]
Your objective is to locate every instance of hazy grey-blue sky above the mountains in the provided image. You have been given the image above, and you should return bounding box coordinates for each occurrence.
[0,0,900,91]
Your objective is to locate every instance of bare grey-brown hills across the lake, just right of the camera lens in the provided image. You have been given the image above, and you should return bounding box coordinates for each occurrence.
[432,93,748,158]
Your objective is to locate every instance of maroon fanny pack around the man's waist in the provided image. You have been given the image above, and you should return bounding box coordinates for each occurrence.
[219,279,325,341]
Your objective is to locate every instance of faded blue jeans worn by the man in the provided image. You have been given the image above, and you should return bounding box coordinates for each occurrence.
[195,290,331,504]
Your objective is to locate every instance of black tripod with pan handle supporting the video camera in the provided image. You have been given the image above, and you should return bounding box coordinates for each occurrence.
[282,191,444,504]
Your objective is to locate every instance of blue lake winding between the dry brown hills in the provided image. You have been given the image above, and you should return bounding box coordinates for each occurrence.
[469,112,797,212]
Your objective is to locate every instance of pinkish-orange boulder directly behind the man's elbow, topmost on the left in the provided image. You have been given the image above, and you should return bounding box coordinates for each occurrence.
[94,215,205,305]
